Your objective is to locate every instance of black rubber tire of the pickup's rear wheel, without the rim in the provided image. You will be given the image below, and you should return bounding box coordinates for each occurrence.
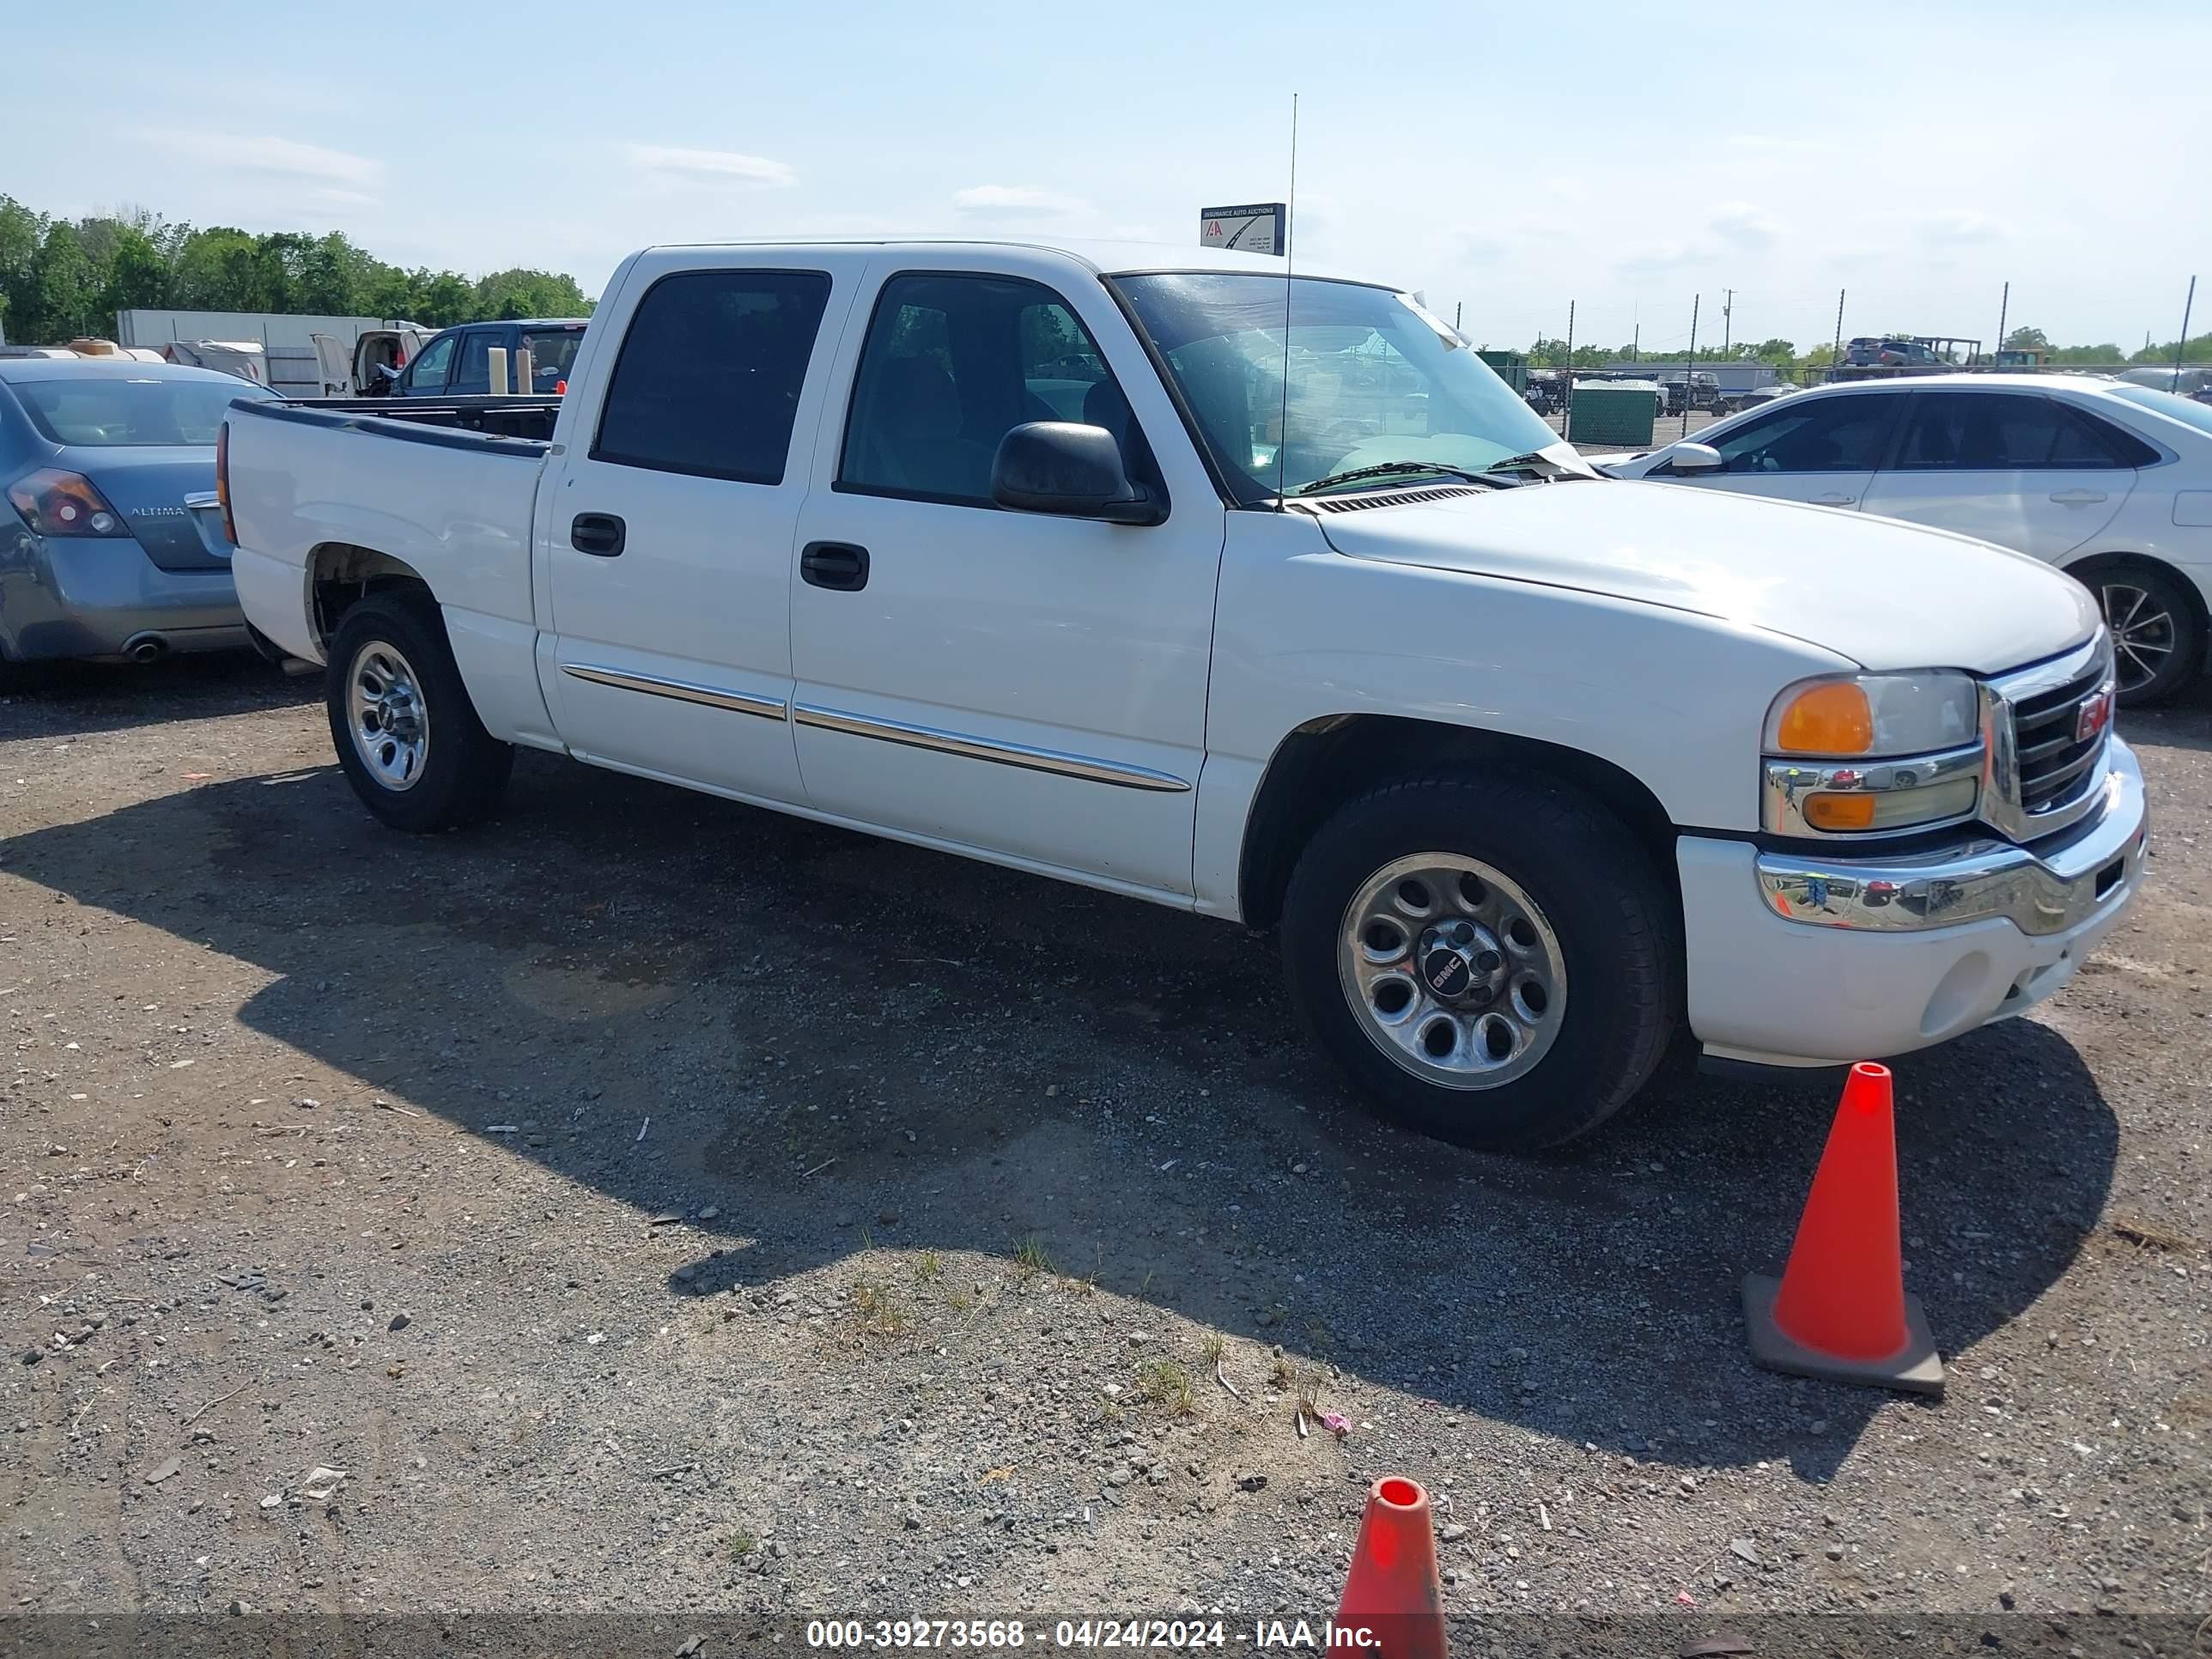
[323,592,515,832]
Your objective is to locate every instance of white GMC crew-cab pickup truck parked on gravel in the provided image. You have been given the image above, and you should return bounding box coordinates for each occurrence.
[222,243,2146,1148]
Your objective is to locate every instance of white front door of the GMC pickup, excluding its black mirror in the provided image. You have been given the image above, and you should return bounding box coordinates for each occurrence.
[790,250,1225,896]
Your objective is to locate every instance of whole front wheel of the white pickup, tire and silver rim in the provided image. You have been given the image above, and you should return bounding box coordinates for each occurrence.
[1283,769,1681,1152]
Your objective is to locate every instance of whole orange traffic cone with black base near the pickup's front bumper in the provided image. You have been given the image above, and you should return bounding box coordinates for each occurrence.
[1743,1064,1942,1394]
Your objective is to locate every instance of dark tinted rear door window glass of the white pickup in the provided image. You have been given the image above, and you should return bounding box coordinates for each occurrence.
[591,270,830,484]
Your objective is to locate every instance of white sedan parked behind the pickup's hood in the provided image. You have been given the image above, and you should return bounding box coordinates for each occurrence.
[1599,374,2212,703]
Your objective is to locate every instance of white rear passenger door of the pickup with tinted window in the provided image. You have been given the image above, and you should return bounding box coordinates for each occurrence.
[538,250,867,805]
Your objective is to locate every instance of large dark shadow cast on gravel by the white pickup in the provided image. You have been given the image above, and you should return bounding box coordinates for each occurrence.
[0,757,2117,1480]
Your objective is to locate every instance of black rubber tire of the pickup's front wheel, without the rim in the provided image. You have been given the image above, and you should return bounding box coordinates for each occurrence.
[1281,768,1681,1152]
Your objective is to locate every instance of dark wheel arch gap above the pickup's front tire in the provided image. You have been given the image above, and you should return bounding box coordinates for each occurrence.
[1237,714,1681,929]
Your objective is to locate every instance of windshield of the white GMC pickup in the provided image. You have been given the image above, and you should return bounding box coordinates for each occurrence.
[1113,272,1559,507]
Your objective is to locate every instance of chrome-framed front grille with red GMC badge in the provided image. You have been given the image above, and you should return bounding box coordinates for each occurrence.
[1984,633,2112,841]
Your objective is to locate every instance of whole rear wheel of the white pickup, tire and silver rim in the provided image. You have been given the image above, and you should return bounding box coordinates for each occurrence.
[323,592,515,832]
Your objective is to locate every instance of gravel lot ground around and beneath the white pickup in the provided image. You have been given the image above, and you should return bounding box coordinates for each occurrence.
[0,664,2212,1614]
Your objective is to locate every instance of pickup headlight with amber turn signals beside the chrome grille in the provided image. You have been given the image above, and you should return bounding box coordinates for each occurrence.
[1763,671,1984,836]
